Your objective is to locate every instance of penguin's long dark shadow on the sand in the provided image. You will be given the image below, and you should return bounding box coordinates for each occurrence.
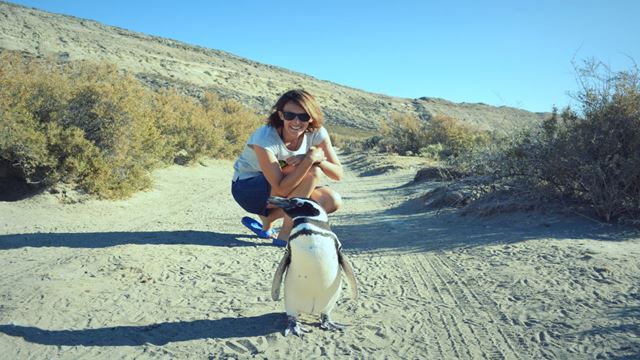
[0,313,287,346]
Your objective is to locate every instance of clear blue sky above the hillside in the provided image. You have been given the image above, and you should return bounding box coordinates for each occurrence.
[6,0,640,111]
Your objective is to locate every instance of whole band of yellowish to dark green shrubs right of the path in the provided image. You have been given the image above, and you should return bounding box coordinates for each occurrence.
[350,61,640,224]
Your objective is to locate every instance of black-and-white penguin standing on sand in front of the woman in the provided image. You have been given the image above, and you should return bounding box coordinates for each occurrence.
[268,196,358,337]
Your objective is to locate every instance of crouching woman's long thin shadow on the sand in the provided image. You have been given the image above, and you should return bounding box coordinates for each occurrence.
[0,230,271,250]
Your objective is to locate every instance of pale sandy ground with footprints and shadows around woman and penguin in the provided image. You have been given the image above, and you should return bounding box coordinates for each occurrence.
[0,155,640,359]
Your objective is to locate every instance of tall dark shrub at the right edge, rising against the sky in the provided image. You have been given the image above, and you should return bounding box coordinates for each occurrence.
[543,62,640,222]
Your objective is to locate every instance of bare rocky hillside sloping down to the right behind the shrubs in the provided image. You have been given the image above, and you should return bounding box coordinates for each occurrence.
[0,2,546,130]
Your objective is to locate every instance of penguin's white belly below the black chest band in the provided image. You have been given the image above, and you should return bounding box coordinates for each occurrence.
[284,236,341,316]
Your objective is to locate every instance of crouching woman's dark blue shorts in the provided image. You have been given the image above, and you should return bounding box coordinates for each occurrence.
[231,174,271,216]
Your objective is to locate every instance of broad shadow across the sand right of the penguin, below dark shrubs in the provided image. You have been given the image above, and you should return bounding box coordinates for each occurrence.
[333,205,640,252]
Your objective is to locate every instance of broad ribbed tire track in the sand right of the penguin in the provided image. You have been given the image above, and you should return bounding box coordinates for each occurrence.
[400,253,531,359]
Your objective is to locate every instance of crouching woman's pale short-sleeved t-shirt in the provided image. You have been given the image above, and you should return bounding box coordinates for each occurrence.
[233,125,329,180]
